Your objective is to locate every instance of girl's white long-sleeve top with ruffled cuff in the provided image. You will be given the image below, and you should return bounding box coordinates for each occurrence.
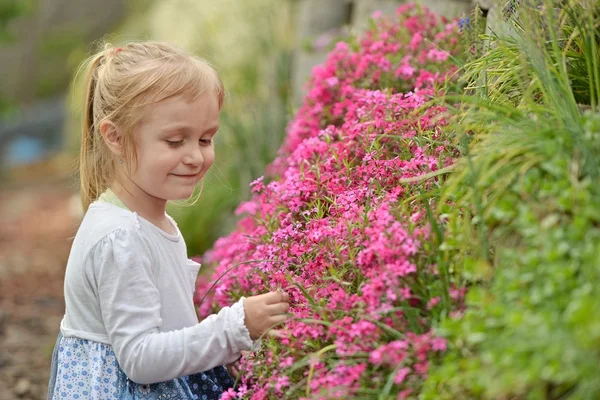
[61,202,253,384]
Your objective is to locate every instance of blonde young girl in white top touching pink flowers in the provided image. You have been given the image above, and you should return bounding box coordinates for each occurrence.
[48,42,289,400]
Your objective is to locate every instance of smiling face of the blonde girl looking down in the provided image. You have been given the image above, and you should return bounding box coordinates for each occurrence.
[130,95,219,200]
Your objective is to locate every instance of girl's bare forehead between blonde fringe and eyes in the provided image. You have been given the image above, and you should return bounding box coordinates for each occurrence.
[140,94,219,129]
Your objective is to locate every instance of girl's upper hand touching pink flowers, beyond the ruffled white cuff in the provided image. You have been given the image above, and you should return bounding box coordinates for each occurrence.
[244,290,290,340]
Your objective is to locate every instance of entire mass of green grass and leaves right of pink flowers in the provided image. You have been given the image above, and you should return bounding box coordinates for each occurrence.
[422,0,600,399]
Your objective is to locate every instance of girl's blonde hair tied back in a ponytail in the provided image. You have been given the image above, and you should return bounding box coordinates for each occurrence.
[76,41,225,211]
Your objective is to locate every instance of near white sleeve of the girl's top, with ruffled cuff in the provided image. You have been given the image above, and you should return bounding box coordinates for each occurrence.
[91,229,253,384]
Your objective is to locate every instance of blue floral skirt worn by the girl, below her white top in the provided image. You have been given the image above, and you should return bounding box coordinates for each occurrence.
[48,334,234,400]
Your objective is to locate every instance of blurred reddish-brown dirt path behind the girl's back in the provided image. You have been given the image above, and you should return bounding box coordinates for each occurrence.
[0,183,79,400]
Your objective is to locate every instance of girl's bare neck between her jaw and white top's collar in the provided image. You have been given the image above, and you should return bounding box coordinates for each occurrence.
[110,176,167,223]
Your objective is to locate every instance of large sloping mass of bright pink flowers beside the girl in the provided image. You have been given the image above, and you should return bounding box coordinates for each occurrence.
[197,5,464,400]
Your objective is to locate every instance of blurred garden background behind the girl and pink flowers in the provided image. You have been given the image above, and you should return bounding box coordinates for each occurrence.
[0,0,471,400]
